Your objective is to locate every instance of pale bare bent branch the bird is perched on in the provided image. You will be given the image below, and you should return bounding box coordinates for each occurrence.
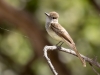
[43,46,100,75]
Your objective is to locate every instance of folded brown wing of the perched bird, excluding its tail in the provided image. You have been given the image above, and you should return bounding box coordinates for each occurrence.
[50,23,74,44]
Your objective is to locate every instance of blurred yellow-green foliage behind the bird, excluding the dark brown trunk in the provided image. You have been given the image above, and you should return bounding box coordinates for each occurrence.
[0,0,100,75]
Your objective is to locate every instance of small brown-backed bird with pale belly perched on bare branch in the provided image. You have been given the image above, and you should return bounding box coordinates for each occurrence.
[45,12,86,67]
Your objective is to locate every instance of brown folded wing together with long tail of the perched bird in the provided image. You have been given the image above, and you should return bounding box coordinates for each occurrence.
[51,23,86,67]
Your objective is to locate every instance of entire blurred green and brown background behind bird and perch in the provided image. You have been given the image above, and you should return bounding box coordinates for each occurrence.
[0,0,100,75]
